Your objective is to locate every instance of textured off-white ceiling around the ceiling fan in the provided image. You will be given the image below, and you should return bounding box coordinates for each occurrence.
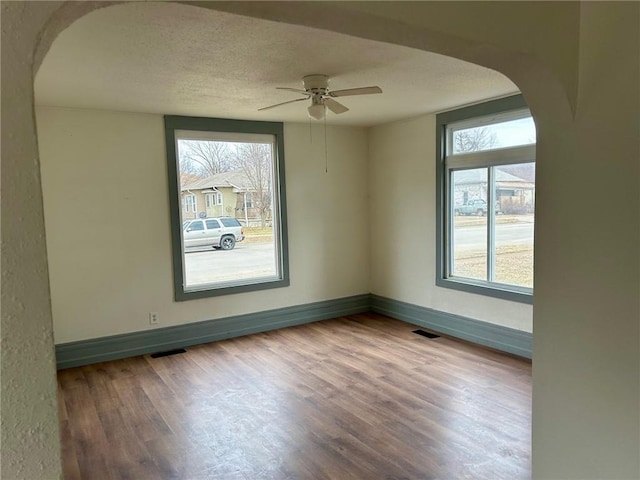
[35,2,517,126]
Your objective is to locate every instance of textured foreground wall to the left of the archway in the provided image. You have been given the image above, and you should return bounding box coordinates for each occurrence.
[0,2,62,480]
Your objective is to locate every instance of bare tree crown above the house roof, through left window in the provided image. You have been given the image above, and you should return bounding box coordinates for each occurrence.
[180,140,234,177]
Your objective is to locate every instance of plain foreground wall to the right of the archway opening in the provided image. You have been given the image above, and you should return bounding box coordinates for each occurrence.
[532,2,640,479]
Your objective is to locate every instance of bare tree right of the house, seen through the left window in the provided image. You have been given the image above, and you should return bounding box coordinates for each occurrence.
[236,143,272,228]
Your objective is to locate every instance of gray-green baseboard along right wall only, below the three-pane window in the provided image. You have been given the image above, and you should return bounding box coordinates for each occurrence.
[371,294,533,358]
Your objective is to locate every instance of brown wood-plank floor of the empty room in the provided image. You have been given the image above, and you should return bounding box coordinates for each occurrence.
[58,314,531,480]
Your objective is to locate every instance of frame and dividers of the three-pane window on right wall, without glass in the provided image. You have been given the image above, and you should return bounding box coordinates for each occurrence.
[436,95,536,304]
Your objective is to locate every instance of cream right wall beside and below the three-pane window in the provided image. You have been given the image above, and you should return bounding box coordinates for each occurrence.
[369,115,533,332]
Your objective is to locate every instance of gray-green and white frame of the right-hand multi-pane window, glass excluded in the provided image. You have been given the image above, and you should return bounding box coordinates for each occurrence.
[436,95,536,303]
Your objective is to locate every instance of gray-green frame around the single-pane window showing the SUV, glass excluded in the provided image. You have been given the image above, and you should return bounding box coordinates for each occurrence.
[164,115,290,301]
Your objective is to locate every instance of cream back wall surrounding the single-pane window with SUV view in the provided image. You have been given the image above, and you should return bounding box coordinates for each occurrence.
[37,108,369,343]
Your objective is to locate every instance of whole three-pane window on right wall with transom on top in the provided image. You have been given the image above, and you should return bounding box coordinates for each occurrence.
[436,95,536,303]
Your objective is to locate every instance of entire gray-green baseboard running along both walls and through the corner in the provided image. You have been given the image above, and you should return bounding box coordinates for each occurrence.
[56,294,532,370]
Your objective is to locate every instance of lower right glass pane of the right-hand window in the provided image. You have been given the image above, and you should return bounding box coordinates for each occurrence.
[494,163,535,288]
